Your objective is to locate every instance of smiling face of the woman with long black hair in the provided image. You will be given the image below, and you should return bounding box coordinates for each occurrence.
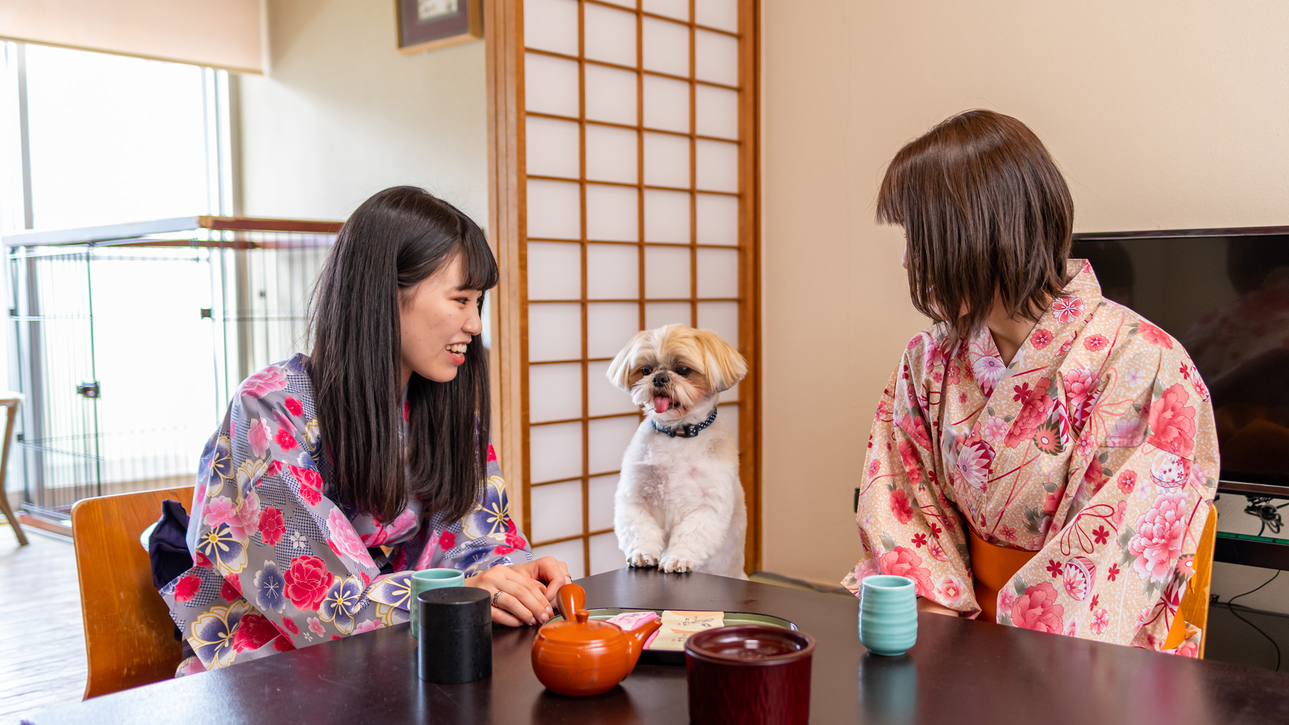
[398,254,483,387]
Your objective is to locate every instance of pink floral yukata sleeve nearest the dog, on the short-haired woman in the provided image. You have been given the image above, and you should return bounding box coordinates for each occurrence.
[842,347,980,614]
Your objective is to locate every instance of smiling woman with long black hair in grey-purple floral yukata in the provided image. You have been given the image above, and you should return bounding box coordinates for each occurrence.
[161,186,571,673]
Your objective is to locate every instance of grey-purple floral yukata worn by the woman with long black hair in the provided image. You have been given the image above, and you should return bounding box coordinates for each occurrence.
[161,355,532,675]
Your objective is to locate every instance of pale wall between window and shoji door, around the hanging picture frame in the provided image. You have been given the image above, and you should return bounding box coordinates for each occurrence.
[238,0,487,224]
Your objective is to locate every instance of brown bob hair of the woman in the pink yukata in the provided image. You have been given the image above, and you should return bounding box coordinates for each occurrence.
[877,110,1074,339]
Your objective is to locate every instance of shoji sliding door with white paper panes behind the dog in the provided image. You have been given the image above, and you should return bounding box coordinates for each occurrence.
[487,0,759,575]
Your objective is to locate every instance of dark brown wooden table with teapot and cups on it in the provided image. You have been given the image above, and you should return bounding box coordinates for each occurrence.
[31,569,1289,725]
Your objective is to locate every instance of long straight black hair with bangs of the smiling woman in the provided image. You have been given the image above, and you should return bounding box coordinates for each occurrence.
[309,186,498,521]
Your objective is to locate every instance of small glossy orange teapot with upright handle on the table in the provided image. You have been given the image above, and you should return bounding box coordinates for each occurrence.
[532,584,663,695]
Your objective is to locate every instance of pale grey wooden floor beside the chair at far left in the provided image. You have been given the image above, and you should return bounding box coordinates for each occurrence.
[0,516,85,722]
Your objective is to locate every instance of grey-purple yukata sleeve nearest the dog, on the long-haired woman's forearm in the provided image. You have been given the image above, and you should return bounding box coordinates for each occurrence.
[416,444,532,577]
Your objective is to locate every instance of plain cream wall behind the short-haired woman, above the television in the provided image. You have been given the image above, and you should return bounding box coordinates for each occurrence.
[762,0,1289,610]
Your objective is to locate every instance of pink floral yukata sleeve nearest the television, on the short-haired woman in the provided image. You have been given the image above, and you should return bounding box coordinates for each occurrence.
[999,346,1218,654]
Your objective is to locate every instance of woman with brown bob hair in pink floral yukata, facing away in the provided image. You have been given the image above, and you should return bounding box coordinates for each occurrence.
[843,111,1218,655]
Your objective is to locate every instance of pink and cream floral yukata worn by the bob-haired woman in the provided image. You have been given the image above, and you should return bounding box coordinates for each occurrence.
[843,259,1218,655]
